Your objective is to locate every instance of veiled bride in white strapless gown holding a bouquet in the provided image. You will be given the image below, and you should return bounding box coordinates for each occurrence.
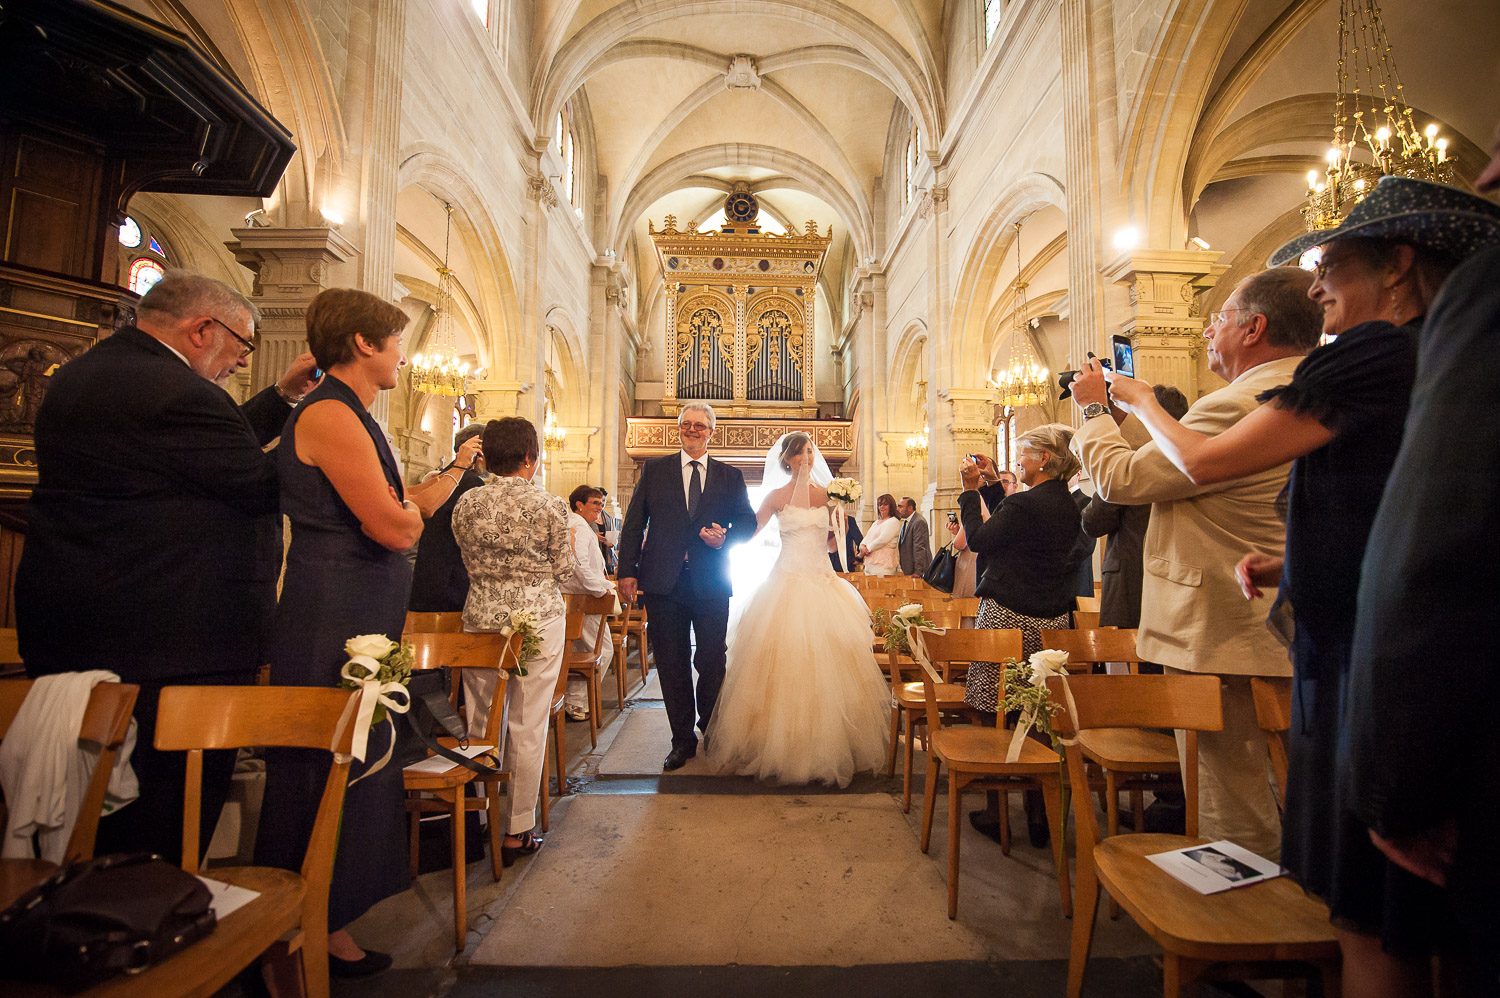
[705,432,891,786]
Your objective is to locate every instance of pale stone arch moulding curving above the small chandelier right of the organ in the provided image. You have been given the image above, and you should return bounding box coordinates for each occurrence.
[938,173,1068,387]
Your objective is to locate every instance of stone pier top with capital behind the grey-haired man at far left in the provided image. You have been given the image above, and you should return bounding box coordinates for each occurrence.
[225,227,355,395]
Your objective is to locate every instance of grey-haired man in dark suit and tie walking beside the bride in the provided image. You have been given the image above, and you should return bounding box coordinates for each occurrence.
[620,402,756,770]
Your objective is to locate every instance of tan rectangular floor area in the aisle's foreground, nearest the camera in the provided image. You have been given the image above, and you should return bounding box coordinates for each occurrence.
[473,792,989,966]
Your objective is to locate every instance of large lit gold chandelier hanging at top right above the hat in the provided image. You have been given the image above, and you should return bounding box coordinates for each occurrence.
[1302,0,1454,233]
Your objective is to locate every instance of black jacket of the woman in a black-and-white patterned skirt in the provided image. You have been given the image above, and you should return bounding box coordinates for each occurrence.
[959,479,1079,617]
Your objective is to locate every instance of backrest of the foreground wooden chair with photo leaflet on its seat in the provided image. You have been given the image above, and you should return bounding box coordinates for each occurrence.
[1047,675,1224,854]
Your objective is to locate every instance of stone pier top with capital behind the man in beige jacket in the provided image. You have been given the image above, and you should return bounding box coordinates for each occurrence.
[1104,249,1229,404]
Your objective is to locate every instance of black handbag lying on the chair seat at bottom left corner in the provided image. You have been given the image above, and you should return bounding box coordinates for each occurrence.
[0,852,218,992]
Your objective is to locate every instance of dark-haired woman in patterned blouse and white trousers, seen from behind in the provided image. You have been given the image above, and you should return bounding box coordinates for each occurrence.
[453,416,573,866]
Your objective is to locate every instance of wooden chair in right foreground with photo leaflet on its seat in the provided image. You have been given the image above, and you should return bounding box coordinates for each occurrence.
[1047,675,1340,998]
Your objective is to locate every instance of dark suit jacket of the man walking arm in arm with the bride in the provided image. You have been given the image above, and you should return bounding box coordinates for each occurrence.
[618,452,756,599]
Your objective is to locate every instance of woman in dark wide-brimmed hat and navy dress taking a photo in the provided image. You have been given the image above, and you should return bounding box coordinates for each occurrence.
[1112,177,1500,995]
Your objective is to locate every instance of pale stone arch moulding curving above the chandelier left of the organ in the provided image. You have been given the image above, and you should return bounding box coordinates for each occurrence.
[396,143,521,378]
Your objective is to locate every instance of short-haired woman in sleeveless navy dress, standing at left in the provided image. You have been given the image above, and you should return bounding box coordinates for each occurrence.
[257,288,422,977]
